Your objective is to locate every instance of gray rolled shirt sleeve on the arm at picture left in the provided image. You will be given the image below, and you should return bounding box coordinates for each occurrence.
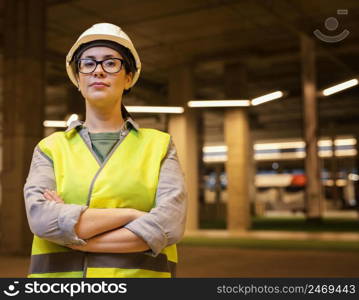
[24,147,87,245]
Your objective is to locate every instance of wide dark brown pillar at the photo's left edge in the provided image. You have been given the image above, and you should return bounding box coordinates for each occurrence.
[0,0,46,254]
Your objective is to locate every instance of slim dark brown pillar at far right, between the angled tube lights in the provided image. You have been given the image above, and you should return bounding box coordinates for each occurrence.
[300,35,322,220]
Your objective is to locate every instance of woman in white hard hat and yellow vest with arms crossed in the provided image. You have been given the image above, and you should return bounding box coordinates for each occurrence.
[24,23,186,277]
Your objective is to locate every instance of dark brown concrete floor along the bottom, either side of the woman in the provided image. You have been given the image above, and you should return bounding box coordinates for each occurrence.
[0,246,359,277]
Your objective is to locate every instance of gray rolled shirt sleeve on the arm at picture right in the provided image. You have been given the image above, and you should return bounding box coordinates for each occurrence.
[124,139,187,256]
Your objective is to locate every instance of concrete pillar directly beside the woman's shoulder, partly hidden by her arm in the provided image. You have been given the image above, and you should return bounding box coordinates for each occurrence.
[168,65,202,231]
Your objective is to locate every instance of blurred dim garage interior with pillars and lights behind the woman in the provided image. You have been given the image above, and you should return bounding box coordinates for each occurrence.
[0,0,359,277]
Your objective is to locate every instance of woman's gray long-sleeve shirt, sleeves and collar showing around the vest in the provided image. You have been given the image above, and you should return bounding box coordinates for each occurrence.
[24,118,186,255]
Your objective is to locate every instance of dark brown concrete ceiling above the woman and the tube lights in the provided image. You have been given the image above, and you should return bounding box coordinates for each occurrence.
[2,0,359,142]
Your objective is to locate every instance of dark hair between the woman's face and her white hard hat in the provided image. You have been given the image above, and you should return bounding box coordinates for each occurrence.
[71,40,137,95]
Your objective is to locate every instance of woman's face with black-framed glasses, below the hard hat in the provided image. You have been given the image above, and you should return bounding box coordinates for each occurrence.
[78,47,132,106]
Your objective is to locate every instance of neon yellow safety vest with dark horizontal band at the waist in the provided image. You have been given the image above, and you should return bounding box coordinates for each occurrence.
[29,128,177,278]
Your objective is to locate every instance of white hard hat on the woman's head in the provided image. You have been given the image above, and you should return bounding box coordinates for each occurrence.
[66,23,141,87]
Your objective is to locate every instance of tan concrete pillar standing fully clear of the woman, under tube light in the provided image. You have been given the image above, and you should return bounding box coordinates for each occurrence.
[224,64,253,231]
